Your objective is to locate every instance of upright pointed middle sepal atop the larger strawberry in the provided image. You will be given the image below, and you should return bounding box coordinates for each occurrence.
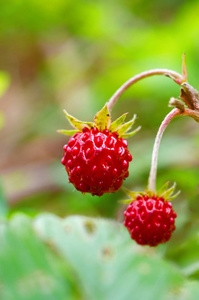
[93,103,111,131]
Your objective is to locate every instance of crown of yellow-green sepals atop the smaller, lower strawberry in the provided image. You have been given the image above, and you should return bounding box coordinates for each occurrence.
[120,181,180,204]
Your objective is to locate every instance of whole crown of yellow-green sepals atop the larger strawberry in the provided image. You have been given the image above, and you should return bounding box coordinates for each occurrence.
[58,103,141,138]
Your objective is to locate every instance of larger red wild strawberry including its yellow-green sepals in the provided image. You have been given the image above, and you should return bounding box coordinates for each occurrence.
[59,105,140,196]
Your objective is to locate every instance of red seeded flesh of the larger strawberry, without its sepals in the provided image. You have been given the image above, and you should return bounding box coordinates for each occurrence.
[62,127,132,196]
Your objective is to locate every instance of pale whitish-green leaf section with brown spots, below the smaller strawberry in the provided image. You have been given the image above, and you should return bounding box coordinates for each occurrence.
[34,214,187,300]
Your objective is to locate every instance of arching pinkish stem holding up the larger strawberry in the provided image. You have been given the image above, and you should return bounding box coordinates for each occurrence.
[108,69,185,110]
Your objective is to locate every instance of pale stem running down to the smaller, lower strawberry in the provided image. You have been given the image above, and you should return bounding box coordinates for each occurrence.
[148,108,182,192]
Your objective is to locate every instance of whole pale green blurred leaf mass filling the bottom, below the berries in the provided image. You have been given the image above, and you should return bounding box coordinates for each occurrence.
[0,214,199,300]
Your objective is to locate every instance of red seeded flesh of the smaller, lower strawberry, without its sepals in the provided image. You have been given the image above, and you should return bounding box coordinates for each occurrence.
[124,195,177,246]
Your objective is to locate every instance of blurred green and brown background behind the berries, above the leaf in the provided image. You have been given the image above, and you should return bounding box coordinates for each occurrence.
[0,0,199,235]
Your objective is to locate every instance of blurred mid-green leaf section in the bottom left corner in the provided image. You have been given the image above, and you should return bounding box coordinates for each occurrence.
[0,214,76,300]
